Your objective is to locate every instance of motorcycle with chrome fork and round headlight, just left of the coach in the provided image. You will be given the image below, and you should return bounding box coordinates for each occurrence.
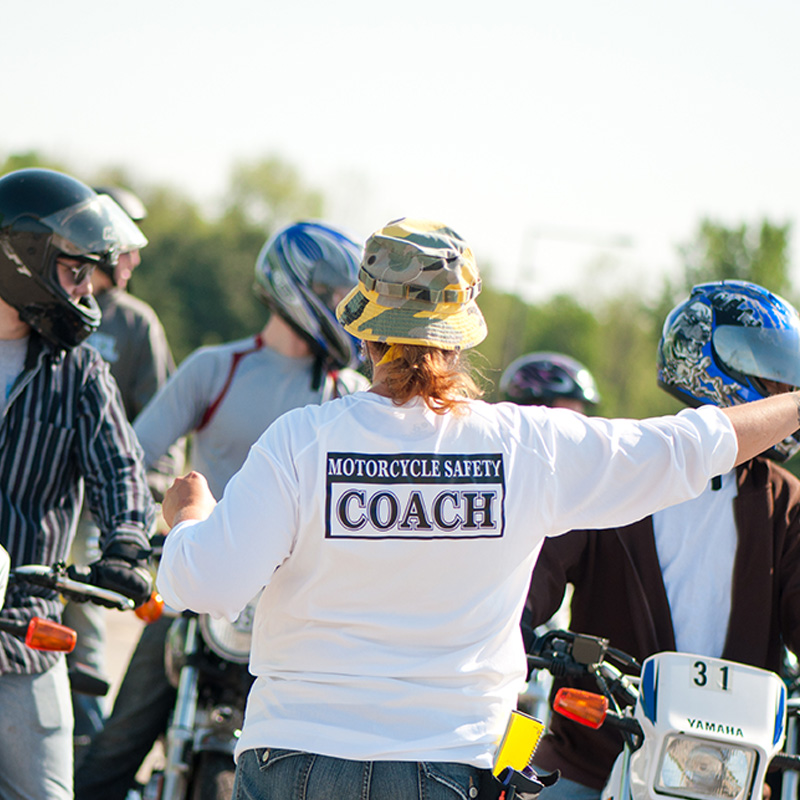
[142,601,255,800]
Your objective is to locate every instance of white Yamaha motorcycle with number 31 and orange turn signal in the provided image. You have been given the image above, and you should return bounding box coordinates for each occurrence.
[528,631,800,800]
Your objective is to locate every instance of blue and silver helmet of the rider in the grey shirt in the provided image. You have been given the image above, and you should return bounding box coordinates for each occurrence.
[253,222,361,369]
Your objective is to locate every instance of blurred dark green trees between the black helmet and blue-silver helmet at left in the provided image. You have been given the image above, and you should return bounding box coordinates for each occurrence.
[133,157,323,361]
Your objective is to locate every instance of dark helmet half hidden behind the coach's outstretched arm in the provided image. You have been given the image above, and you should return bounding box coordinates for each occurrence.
[500,353,600,406]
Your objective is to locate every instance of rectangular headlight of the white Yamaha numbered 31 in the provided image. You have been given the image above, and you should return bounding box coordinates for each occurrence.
[655,736,758,800]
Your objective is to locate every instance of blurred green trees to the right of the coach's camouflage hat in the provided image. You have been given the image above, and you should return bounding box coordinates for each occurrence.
[478,212,800,424]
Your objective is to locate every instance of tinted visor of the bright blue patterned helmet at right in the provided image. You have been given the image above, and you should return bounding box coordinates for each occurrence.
[713,325,800,387]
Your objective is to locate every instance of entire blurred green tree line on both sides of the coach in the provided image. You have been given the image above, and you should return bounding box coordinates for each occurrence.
[0,152,793,424]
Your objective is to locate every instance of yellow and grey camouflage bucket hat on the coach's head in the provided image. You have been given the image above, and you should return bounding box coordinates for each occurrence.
[336,217,488,350]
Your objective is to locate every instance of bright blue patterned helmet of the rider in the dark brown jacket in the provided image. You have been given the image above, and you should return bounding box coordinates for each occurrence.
[658,281,800,461]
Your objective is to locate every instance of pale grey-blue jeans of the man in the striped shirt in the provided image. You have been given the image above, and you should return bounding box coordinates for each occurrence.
[0,658,72,800]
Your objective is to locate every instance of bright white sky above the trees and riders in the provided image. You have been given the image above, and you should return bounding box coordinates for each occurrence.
[0,0,800,299]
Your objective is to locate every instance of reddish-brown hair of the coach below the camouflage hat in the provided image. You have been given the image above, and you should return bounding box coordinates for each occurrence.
[370,342,483,414]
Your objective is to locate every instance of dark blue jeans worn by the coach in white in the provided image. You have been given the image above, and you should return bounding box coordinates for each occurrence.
[233,748,485,800]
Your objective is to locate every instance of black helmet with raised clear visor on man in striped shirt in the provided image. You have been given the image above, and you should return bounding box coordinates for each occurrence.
[0,169,146,349]
